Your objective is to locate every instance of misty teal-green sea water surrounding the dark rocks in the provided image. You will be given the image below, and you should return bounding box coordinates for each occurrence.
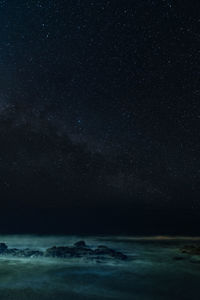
[0,236,200,300]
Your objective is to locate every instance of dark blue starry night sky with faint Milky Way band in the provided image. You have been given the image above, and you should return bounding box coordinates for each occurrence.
[0,0,200,234]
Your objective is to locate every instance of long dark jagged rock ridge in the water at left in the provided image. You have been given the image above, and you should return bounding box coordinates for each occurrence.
[0,241,127,260]
